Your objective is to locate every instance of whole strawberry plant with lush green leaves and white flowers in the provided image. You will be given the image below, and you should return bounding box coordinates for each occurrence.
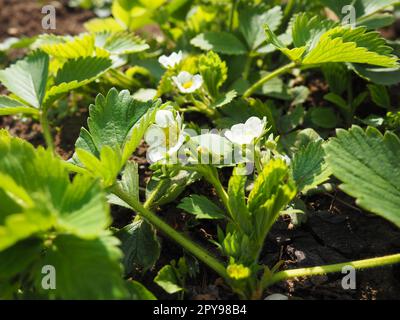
[0,0,400,299]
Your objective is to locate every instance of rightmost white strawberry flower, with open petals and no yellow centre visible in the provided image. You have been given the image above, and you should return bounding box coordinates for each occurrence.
[225,117,266,145]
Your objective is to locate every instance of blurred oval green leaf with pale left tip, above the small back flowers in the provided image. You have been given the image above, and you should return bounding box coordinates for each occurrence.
[190,32,247,55]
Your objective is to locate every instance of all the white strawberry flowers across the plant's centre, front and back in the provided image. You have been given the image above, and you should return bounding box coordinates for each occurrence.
[152,51,290,168]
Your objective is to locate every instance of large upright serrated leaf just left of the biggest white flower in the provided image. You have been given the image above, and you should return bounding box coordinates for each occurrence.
[73,89,159,185]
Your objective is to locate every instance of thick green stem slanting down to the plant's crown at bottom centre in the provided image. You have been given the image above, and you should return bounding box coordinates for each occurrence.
[112,185,228,279]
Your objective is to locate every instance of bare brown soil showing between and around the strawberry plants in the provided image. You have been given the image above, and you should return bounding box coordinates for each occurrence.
[0,0,400,300]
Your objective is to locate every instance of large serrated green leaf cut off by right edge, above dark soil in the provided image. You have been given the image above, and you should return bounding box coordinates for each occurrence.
[325,126,400,227]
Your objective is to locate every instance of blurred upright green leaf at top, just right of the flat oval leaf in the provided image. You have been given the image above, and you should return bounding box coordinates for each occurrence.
[239,6,283,50]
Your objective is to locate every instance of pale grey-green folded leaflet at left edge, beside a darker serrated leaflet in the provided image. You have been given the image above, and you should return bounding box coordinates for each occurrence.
[0,51,49,109]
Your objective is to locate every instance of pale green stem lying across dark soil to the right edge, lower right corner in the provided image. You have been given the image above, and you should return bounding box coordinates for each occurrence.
[263,254,400,288]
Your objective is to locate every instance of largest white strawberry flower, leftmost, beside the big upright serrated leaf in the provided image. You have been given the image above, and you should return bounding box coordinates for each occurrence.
[144,109,186,163]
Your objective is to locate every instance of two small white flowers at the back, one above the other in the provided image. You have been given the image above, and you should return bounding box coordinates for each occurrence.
[158,51,203,93]
